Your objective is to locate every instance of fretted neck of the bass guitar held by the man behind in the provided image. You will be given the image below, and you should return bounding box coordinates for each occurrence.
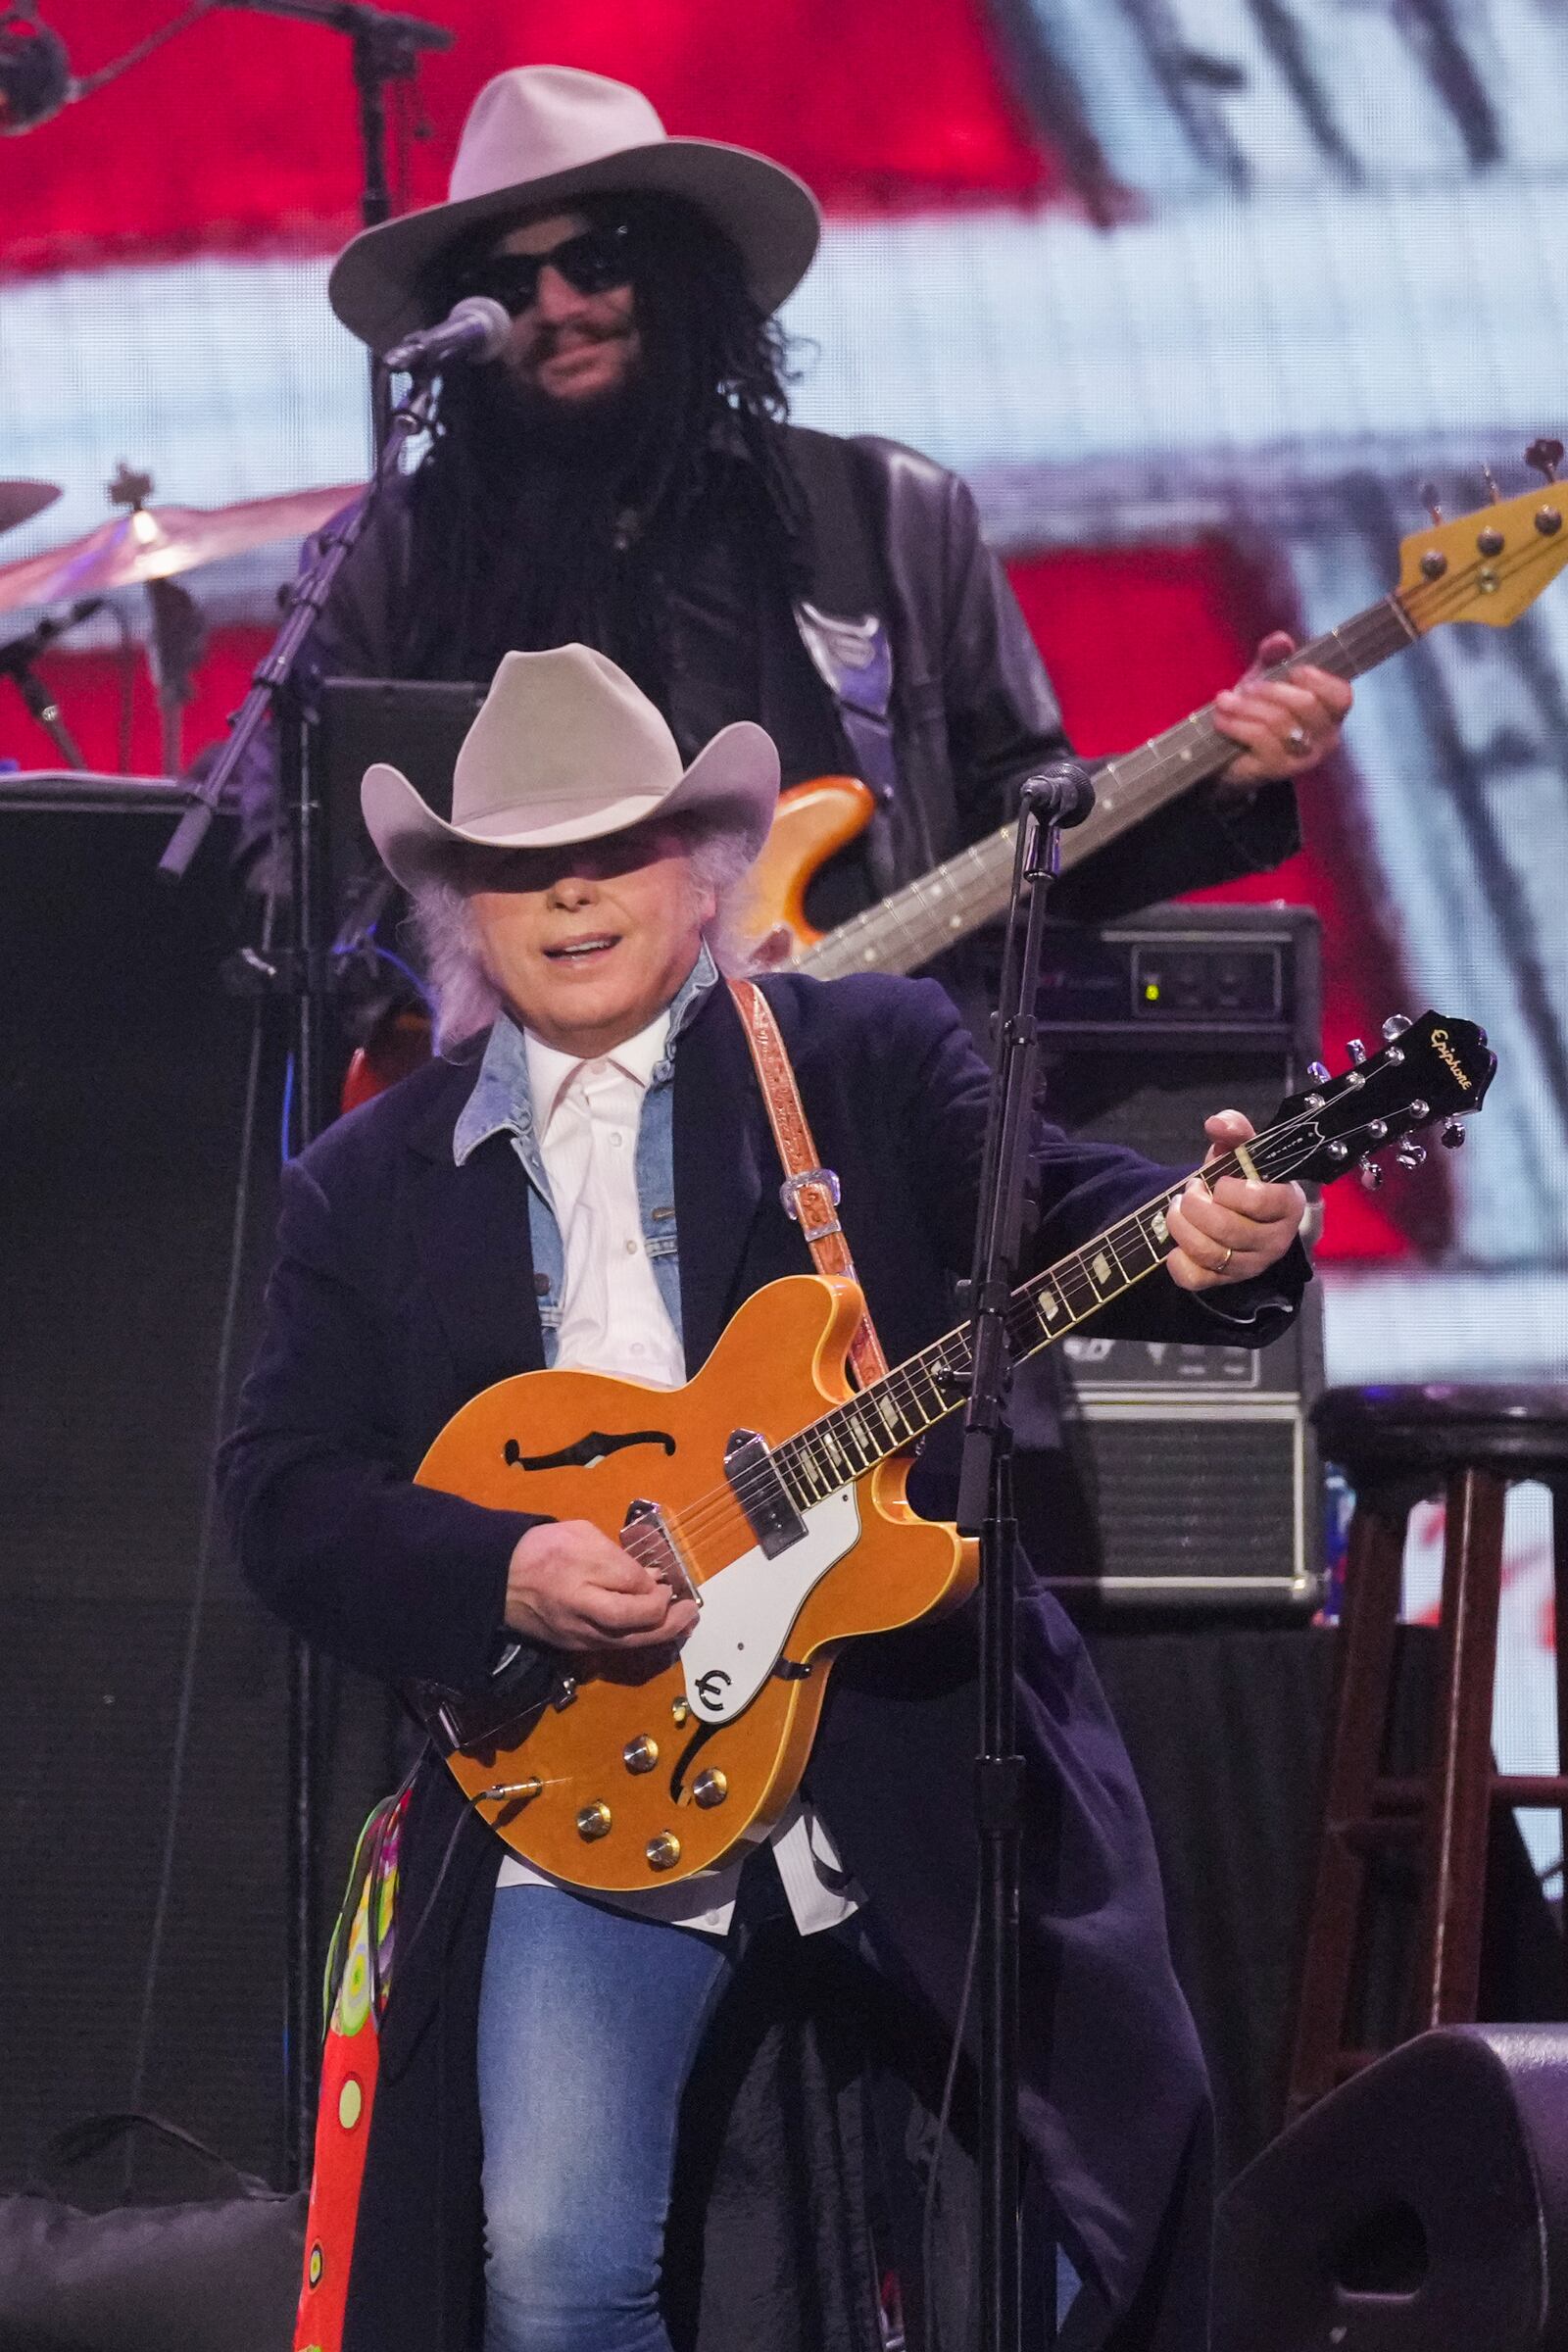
[790,595,1420,981]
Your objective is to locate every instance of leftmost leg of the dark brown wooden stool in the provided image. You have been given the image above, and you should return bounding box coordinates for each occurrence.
[1286,1503,1408,2124]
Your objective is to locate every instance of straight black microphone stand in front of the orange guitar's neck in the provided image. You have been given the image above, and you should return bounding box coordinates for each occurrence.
[959,760,1093,2352]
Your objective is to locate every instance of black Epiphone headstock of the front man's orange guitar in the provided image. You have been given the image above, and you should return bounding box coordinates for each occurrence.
[1249,1013,1497,1186]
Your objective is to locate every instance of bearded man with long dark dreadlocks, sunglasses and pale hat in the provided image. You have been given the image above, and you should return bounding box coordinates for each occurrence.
[230,66,1349,941]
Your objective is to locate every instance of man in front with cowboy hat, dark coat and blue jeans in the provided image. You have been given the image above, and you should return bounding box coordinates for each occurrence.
[223,645,1304,2352]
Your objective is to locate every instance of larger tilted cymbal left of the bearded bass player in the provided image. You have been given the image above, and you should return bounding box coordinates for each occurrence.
[0,482,360,612]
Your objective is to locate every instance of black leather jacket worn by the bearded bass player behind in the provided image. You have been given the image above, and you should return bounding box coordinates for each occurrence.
[226,425,1298,922]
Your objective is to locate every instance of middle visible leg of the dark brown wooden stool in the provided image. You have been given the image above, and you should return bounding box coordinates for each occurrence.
[1415,1468,1507,2030]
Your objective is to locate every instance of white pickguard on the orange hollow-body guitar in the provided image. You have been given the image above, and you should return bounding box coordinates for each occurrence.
[682,1487,860,1724]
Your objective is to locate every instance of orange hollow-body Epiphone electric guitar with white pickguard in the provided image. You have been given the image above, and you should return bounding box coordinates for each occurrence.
[414,1013,1495,1893]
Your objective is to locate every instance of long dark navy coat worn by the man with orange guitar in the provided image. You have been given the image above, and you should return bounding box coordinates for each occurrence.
[223,976,1307,2352]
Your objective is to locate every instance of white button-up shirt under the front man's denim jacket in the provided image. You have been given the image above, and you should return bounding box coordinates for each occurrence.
[496,1011,862,1936]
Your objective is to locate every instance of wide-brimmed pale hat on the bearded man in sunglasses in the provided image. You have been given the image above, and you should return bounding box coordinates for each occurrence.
[326,66,823,351]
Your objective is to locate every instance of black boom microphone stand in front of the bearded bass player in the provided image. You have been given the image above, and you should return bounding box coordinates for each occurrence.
[160,383,430,2185]
